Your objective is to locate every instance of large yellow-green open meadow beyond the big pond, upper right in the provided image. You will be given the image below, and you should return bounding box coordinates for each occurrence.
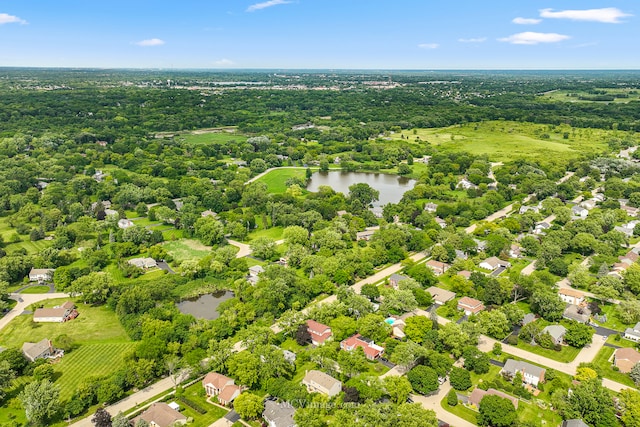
[396,121,608,161]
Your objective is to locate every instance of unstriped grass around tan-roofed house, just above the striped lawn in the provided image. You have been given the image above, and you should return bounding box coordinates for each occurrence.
[0,299,131,348]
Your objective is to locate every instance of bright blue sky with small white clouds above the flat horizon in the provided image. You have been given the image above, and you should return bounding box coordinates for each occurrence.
[0,0,640,69]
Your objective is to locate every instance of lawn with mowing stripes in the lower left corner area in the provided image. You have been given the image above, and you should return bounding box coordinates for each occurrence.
[54,342,136,400]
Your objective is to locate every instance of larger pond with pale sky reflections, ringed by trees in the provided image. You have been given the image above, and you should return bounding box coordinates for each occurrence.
[307,171,416,206]
